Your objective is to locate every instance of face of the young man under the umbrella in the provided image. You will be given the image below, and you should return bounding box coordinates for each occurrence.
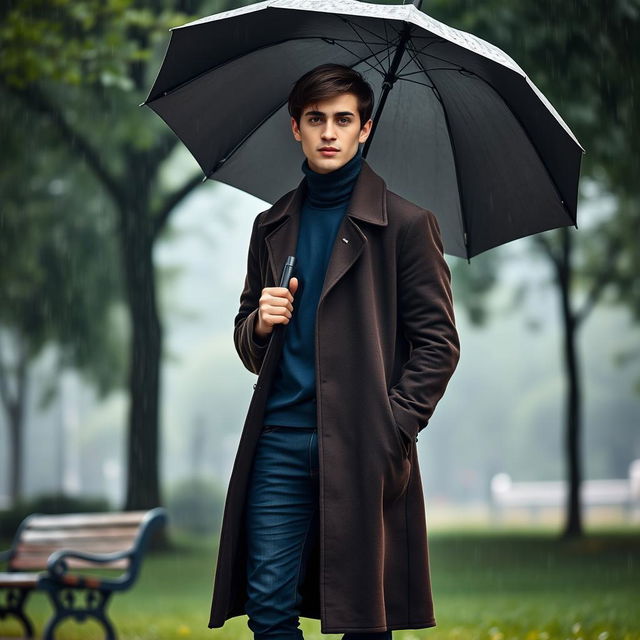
[291,93,373,173]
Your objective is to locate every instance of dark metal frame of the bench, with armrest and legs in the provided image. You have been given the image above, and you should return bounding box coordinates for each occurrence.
[0,507,167,640]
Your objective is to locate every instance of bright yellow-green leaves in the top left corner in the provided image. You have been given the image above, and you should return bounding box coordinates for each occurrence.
[0,0,187,91]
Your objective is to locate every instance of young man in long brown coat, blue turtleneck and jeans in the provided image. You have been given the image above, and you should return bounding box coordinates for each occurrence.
[209,64,459,640]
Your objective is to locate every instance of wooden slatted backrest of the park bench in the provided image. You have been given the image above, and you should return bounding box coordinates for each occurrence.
[8,508,164,571]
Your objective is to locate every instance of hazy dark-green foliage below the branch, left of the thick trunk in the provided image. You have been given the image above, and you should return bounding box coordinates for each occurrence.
[0,87,127,393]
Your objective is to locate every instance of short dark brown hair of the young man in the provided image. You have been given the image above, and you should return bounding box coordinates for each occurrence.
[288,63,374,129]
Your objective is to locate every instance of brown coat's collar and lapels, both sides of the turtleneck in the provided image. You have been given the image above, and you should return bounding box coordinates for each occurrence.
[259,159,388,305]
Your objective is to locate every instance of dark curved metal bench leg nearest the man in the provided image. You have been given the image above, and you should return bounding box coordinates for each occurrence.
[42,587,116,640]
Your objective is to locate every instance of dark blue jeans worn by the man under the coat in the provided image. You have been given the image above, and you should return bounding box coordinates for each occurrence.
[244,426,391,640]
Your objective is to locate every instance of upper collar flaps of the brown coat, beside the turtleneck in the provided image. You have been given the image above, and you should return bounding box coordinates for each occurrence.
[258,158,388,227]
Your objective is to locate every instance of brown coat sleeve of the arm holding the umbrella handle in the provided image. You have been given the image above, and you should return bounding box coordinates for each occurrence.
[233,216,273,374]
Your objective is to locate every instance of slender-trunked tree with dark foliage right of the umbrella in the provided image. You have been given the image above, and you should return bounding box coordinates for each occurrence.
[431,0,640,537]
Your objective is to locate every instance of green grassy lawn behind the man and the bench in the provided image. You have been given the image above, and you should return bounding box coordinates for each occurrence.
[0,530,640,640]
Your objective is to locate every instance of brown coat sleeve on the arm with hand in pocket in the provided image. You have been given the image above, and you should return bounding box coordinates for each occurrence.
[389,209,460,440]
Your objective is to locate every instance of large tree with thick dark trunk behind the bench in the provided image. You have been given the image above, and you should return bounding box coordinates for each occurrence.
[0,0,244,509]
